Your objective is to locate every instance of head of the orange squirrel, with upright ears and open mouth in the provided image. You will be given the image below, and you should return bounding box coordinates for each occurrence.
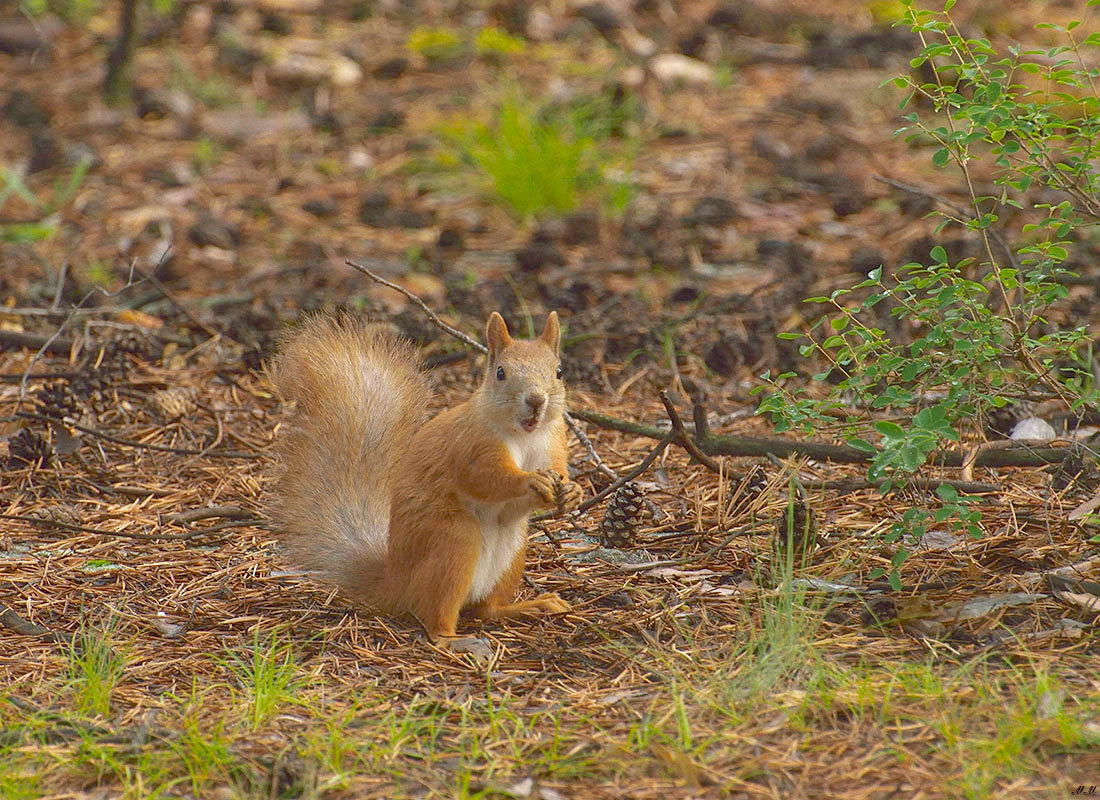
[482,311,565,434]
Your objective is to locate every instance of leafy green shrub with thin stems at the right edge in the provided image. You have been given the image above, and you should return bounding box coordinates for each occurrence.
[757,0,1100,585]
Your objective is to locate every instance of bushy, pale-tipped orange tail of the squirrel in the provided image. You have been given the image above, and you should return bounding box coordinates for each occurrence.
[273,316,431,607]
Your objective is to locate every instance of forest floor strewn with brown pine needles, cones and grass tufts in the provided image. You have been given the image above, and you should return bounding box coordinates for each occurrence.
[0,0,1100,800]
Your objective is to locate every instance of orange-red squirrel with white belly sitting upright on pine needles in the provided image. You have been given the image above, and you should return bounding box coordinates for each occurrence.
[273,313,582,646]
